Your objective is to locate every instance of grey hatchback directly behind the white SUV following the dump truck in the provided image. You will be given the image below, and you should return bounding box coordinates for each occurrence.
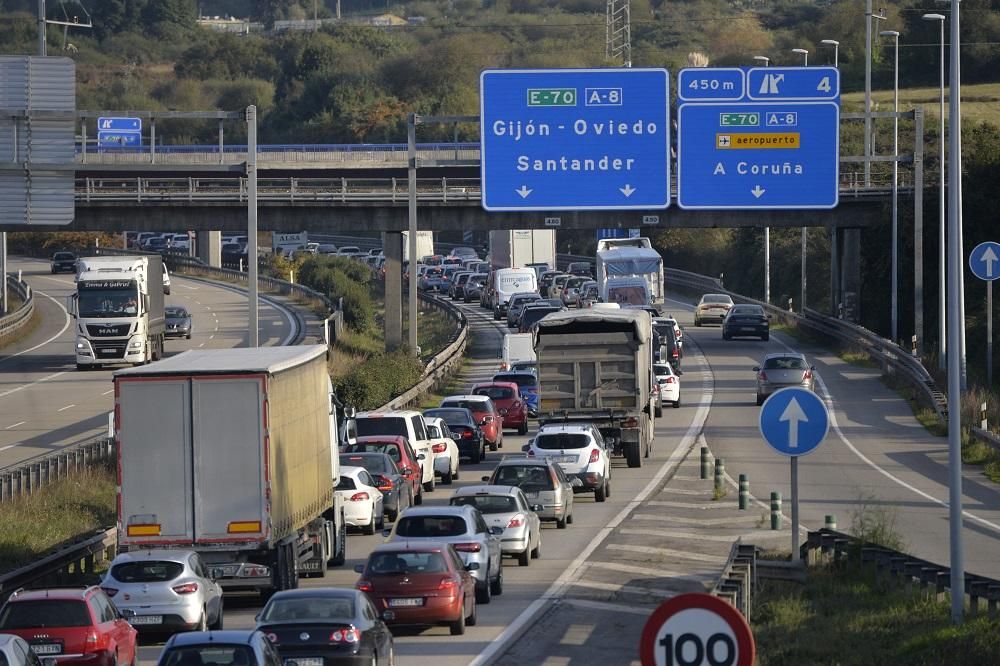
[483,458,573,529]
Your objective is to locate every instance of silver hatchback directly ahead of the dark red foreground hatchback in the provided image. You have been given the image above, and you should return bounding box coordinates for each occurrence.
[383,506,503,604]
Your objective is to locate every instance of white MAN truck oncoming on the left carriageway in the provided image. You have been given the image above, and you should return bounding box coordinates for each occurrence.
[66,254,166,370]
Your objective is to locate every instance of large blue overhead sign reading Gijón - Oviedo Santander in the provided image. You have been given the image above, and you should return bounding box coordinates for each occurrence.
[480,69,670,211]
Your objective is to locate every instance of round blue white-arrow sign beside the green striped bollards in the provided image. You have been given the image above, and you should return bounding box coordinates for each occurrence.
[760,387,830,456]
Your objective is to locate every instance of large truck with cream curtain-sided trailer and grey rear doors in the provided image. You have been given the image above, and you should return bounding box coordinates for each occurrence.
[114,345,347,598]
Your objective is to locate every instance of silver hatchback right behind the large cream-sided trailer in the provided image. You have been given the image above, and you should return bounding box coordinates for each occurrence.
[101,550,223,632]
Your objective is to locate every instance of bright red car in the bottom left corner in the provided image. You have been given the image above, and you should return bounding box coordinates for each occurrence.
[0,586,137,666]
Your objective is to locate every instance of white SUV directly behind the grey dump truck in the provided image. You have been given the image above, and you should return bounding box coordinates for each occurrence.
[524,423,611,502]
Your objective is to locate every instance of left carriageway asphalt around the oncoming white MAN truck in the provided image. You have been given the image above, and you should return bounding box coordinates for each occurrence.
[0,257,296,468]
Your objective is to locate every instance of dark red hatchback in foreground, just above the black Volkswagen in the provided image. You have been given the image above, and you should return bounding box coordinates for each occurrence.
[355,541,479,636]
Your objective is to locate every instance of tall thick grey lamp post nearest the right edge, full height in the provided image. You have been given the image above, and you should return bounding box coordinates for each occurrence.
[948,0,965,624]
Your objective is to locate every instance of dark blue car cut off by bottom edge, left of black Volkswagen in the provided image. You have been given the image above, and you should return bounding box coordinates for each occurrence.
[157,630,281,666]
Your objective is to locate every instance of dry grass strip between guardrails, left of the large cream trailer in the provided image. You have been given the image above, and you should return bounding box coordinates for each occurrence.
[0,466,115,571]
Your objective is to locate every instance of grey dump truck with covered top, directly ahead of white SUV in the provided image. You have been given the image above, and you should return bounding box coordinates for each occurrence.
[535,309,656,467]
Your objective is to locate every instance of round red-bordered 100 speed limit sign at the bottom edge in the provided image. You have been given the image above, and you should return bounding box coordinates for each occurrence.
[639,592,754,666]
